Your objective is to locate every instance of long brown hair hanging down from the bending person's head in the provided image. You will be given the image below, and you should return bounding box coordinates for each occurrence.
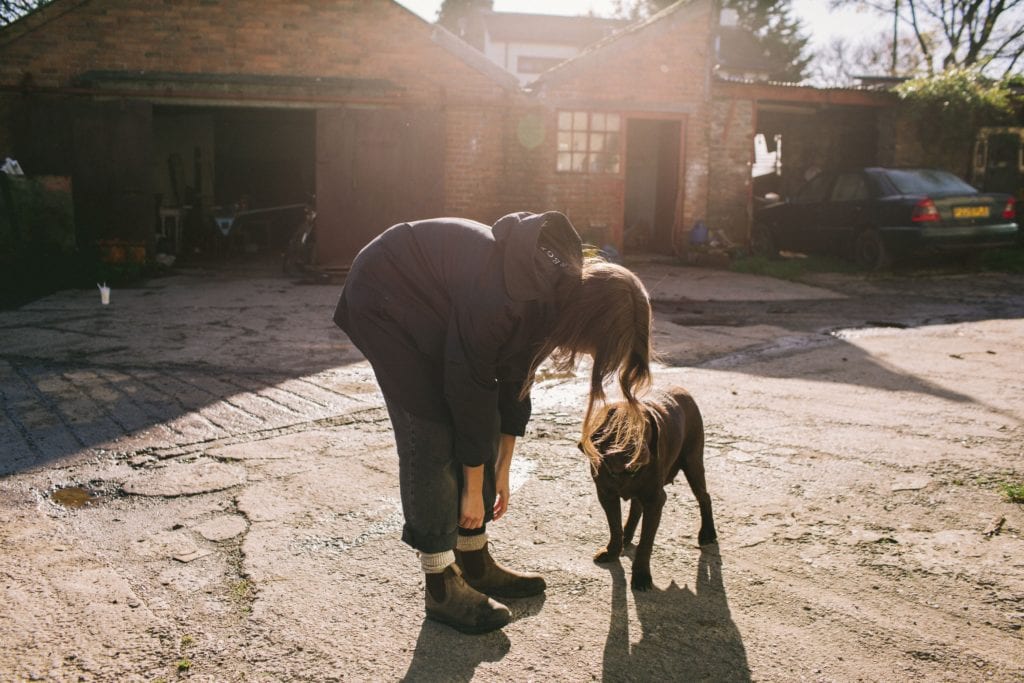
[524,259,651,465]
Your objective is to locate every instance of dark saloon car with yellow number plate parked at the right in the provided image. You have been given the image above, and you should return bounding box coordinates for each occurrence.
[752,167,1019,269]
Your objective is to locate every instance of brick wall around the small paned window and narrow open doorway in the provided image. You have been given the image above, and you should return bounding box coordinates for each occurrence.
[540,0,713,247]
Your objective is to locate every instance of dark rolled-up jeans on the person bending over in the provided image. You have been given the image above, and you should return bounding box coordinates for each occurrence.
[384,394,499,553]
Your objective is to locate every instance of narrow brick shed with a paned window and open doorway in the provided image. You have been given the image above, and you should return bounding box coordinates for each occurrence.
[531,0,717,253]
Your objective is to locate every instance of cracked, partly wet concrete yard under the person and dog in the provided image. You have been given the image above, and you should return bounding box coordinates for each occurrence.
[0,263,1024,681]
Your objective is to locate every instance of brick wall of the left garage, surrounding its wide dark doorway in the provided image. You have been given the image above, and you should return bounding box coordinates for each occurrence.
[0,0,538,245]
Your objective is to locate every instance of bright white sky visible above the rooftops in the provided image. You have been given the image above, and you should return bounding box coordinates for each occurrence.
[397,0,889,49]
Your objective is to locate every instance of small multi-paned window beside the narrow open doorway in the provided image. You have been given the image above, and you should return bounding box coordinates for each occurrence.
[556,112,622,173]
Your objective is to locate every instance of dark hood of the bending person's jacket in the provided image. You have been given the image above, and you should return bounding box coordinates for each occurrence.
[493,211,583,301]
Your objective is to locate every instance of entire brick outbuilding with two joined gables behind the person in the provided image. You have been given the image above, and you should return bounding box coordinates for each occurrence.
[0,0,897,264]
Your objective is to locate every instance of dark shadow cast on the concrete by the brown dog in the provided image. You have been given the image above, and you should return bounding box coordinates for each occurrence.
[602,544,751,681]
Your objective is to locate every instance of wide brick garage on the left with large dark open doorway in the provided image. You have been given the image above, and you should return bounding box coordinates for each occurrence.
[0,0,523,263]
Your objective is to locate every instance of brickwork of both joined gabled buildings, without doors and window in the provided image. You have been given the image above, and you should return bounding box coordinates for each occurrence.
[0,0,712,252]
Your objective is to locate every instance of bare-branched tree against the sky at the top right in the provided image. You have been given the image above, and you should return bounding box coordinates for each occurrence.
[830,0,1024,76]
